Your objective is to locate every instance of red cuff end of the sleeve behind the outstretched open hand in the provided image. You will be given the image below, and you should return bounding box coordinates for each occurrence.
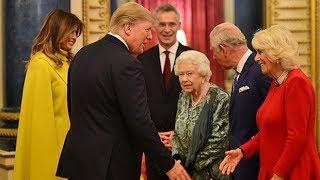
[240,133,260,159]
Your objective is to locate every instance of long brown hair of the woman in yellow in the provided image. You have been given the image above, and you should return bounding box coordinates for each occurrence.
[29,9,83,67]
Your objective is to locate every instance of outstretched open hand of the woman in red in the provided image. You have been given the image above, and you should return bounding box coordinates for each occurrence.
[219,148,243,175]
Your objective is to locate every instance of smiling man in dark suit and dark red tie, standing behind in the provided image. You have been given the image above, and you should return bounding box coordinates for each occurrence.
[138,4,191,180]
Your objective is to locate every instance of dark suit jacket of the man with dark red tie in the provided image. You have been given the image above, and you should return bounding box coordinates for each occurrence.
[138,43,191,132]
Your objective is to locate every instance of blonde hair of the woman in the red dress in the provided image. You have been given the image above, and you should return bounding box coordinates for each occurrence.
[252,25,299,70]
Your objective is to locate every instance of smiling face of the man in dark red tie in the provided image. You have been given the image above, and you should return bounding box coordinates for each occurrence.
[155,11,181,49]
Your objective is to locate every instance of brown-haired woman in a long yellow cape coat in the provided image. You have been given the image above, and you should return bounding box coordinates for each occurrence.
[13,9,83,180]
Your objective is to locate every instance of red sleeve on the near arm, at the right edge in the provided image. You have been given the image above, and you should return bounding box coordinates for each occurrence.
[273,77,312,177]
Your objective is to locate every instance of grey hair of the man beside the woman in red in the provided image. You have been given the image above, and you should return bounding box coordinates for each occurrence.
[209,22,247,51]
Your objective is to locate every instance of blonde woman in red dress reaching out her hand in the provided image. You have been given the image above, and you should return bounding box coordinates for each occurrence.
[220,25,320,180]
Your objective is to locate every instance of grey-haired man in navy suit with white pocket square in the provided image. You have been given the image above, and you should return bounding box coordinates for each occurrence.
[210,23,270,180]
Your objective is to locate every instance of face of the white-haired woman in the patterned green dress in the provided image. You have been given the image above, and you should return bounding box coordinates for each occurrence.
[178,62,205,94]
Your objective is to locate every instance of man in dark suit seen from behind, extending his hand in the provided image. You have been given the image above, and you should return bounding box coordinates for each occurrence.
[57,2,190,180]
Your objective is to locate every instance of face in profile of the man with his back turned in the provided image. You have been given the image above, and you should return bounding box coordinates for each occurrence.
[128,20,152,55]
